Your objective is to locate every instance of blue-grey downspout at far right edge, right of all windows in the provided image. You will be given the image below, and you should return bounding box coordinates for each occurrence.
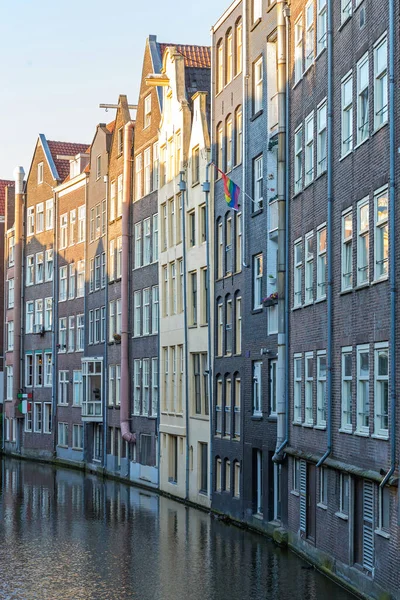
[380,0,397,488]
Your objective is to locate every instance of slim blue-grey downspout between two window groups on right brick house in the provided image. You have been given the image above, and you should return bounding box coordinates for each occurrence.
[317,0,333,467]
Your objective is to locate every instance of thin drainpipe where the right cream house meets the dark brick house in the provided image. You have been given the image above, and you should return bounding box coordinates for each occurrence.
[203,161,214,502]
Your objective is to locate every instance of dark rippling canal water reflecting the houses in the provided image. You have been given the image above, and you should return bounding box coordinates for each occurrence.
[0,458,353,600]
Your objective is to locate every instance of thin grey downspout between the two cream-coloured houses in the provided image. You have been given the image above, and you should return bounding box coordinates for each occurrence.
[179,171,189,500]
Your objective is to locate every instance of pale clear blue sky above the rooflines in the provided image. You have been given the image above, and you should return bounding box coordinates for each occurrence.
[0,0,230,179]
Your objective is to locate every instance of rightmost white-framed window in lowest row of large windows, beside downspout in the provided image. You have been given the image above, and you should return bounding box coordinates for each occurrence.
[374,343,389,437]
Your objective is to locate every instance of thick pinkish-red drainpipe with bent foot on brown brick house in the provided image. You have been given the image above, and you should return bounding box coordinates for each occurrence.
[120,121,136,444]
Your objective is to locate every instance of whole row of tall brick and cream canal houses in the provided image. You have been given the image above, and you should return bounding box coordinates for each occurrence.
[0,0,400,598]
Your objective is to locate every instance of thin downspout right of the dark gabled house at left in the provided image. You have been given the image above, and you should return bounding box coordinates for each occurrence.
[51,188,58,455]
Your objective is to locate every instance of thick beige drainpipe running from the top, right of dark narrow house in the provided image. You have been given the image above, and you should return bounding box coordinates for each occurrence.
[273,0,290,462]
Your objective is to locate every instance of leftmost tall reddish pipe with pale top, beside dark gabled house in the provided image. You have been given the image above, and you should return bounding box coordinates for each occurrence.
[13,167,25,452]
